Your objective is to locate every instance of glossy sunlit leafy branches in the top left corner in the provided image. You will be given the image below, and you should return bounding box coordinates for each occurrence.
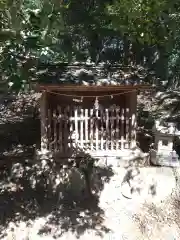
[0,0,67,90]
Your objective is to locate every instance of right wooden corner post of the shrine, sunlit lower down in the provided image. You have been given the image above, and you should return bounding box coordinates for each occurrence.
[129,91,137,148]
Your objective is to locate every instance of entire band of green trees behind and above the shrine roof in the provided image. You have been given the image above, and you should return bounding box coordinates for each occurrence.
[0,0,180,89]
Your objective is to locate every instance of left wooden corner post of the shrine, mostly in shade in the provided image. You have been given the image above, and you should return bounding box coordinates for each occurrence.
[40,92,48,151]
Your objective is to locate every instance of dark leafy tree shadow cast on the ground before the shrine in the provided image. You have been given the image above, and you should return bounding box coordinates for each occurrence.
[0,148,113,238]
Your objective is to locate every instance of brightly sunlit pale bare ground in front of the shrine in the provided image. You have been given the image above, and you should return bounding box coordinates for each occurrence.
[1,167,180,240]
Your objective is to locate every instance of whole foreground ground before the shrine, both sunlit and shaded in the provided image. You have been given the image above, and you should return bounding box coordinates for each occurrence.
[0,155,180,240]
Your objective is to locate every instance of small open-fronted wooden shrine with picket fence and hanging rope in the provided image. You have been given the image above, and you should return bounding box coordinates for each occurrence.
[39,84,149,157]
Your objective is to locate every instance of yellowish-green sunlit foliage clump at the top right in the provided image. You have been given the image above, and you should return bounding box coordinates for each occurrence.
[107,0,167,44]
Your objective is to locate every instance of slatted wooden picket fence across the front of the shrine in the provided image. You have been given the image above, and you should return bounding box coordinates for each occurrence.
[47,105,136,153]
